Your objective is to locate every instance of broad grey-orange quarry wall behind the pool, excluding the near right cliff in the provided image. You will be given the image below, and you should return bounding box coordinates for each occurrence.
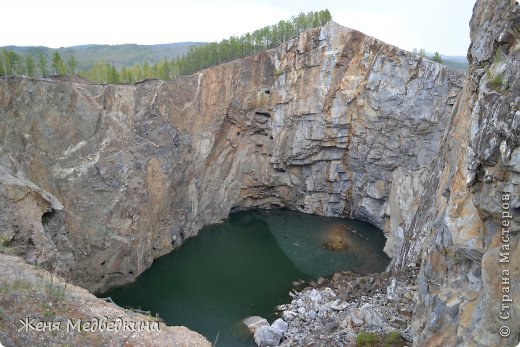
[0,23,463,291]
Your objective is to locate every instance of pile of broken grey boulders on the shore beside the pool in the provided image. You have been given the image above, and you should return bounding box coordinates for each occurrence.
[244,264,419,346]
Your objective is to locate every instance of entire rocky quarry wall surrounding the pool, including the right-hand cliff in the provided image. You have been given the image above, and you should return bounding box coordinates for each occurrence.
[0,0,520,345]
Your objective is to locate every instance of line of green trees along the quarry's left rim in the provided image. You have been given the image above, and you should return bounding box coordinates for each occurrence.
[0,10,332,83]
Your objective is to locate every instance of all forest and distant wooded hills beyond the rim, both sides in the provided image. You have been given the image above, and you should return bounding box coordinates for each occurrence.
[0,10,467,83]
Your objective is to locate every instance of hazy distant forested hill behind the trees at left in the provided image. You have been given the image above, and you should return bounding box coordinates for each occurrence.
[0,42,204,70]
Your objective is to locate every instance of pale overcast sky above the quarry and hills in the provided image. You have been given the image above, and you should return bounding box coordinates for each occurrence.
[0,0,474,55]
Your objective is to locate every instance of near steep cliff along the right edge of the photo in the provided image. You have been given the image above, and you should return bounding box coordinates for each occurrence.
[406,0,520,346]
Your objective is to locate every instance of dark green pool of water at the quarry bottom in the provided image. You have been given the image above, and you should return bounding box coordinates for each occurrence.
[102,210,389,346]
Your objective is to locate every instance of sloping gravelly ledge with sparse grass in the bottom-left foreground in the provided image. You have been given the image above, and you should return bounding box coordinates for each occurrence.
[0,254,212,347]
